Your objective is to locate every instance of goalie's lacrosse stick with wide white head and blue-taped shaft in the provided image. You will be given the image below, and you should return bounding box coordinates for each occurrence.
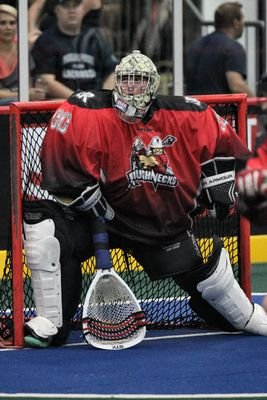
[83,218,146,350]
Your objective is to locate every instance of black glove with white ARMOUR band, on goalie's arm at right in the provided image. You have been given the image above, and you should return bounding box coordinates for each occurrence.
[200,157,237,219]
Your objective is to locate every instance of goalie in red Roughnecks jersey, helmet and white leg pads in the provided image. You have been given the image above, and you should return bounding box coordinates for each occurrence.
[24,50,267,347]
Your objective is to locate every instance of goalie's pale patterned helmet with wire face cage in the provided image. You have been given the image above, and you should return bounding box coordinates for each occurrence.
[113,50,160,123]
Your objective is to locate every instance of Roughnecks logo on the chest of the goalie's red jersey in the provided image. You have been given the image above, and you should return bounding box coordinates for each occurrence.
[127,135,178,191]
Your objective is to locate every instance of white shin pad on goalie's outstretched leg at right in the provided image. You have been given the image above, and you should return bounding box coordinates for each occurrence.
[197,248,253,330]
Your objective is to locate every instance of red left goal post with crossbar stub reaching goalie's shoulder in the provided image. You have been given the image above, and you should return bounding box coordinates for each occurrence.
[9,101,62,347]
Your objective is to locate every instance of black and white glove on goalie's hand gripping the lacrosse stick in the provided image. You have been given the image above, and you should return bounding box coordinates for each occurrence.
[56,183,114,220]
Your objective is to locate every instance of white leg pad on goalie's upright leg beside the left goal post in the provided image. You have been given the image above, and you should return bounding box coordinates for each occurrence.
[23,219,62,327]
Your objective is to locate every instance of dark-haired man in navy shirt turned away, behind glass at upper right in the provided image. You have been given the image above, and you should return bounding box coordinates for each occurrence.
[184,2,253,96]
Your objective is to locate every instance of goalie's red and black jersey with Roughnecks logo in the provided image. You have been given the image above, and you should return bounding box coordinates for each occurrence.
[41,91,249,244]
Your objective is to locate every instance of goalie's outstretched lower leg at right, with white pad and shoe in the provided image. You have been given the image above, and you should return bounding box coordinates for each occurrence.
[176,237,267,336]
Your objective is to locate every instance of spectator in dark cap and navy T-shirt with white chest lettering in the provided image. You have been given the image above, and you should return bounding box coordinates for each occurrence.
[32,0,117,99]
